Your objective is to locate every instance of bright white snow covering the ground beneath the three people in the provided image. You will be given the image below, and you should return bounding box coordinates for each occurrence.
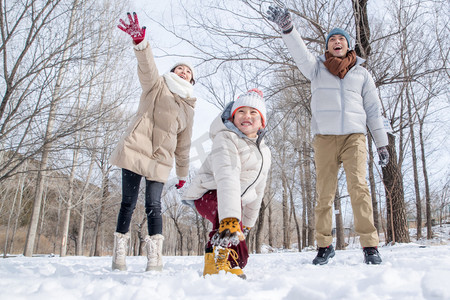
[0,227,450,300]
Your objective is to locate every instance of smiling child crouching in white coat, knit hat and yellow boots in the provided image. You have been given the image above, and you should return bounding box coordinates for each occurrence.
[183,89,271,278]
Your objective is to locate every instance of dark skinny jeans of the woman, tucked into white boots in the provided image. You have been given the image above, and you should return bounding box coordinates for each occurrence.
[116,169,164,235]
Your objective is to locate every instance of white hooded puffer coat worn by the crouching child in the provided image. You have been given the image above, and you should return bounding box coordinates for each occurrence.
[183,102,271,227]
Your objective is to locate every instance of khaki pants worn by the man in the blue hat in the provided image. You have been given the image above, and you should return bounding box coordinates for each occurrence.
[314,133,379,247]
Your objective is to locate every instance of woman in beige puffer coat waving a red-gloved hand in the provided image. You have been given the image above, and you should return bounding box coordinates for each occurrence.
[110,13,196,271]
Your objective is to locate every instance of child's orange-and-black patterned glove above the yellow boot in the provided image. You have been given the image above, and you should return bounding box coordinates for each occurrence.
[211,218,245,248]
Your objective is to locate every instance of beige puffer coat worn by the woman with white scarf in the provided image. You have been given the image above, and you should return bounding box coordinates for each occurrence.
[110,44,196,183]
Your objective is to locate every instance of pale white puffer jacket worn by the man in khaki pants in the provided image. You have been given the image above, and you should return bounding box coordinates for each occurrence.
[282,28,388,147]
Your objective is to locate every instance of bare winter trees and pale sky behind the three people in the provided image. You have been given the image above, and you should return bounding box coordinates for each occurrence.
[0,0,450,257]
